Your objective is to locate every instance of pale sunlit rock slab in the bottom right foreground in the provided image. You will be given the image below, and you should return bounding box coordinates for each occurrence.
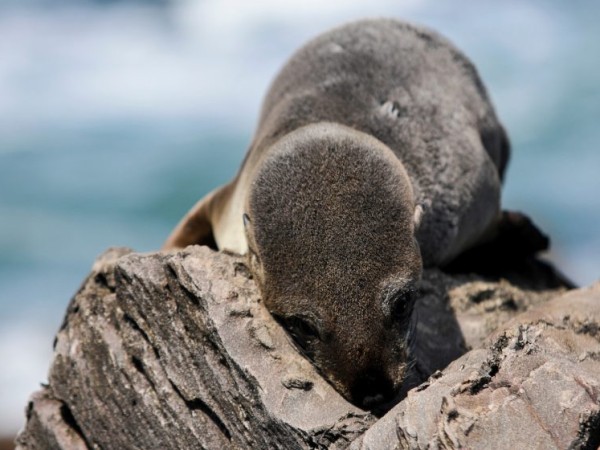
[350,283,600,449]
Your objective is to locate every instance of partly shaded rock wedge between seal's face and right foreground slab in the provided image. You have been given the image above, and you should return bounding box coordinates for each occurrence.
[405,269,565,389]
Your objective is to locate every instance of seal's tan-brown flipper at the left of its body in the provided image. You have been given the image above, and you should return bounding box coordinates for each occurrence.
[162,184,232,250]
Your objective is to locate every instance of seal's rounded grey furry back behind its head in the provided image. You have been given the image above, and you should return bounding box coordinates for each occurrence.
[251,20,509,266]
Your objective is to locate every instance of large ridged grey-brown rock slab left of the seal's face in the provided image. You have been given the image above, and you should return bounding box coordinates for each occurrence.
[19,247,374,449]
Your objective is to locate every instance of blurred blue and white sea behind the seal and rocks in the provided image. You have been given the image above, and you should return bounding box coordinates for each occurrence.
[0,0,600,435]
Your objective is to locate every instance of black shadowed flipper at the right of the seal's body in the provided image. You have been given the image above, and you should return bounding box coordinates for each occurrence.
[444,211,573,287]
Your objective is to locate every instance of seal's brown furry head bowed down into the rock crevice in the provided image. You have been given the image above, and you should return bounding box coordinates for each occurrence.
[244,123,422,408]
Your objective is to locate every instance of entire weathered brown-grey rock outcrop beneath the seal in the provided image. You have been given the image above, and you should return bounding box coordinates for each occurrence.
[17,247,600,449]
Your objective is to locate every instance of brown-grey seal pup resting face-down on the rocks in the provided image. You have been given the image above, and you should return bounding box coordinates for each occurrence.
[164,19,540,408]
